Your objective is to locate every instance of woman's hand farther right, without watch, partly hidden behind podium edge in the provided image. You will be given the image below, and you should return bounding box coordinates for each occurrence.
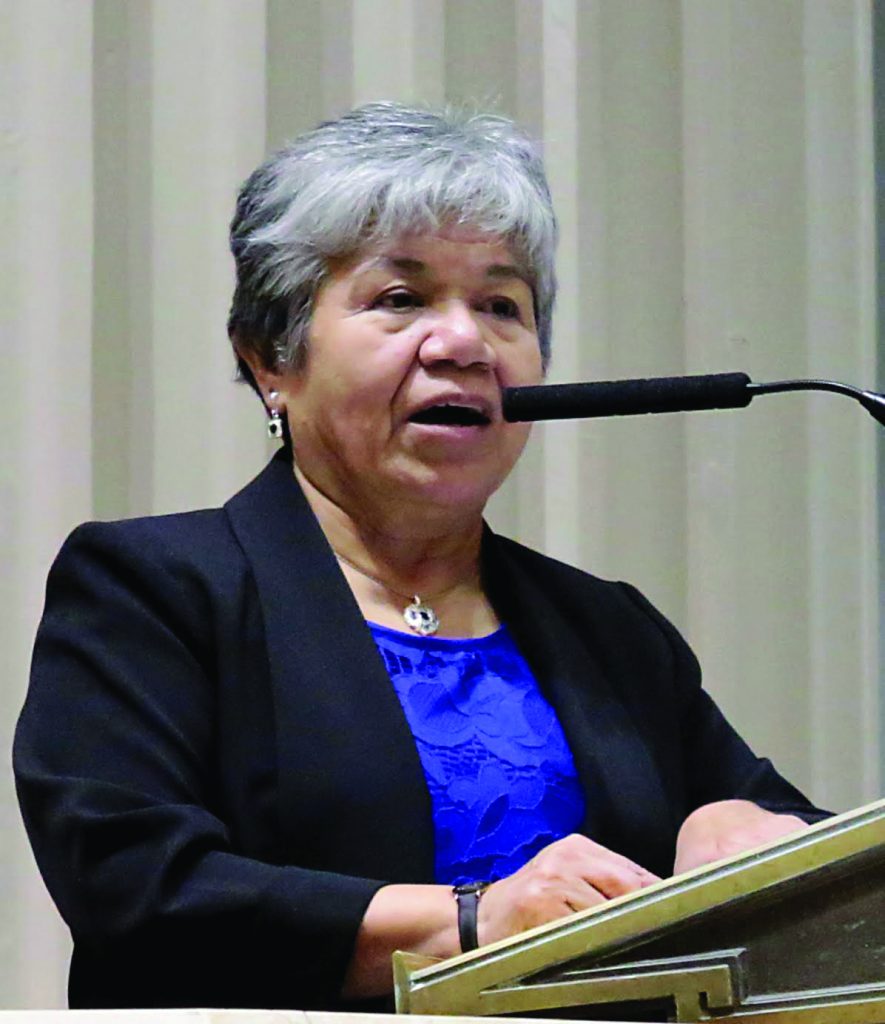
[673,800,808,874]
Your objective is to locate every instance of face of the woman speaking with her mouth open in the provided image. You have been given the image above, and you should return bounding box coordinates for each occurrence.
[275,227,542,524]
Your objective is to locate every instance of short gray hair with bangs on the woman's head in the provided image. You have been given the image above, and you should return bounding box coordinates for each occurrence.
[227,102,556,384]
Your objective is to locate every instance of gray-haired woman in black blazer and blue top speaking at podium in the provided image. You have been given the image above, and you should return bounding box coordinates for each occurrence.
[15,104,820,1008]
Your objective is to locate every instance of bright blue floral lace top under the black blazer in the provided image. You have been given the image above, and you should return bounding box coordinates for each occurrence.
[370,623,584,885]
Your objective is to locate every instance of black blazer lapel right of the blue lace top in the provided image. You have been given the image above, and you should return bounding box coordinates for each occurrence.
[483,529,675,872]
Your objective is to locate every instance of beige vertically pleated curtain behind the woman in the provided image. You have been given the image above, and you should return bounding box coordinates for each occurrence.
[0,0,881,1007]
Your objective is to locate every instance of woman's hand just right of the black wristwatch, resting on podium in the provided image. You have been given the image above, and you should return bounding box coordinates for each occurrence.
[477,836,659,945]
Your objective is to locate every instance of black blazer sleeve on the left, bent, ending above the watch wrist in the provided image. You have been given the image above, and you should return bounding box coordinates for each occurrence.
[14,520,383,1008]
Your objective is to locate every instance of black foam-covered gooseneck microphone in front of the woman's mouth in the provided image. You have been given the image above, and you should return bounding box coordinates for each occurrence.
[502,373,885,424]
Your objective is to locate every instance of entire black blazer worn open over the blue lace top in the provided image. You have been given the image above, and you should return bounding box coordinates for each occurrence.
[15,452,823,1009]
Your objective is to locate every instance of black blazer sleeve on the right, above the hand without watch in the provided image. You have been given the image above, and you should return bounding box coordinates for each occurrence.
[621,584,831,823]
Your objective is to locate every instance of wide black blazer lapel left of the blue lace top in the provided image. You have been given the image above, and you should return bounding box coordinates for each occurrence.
[225,450,433,882]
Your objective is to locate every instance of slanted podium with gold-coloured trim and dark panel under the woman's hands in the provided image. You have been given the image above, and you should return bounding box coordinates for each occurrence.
[394,800,885,1024]
